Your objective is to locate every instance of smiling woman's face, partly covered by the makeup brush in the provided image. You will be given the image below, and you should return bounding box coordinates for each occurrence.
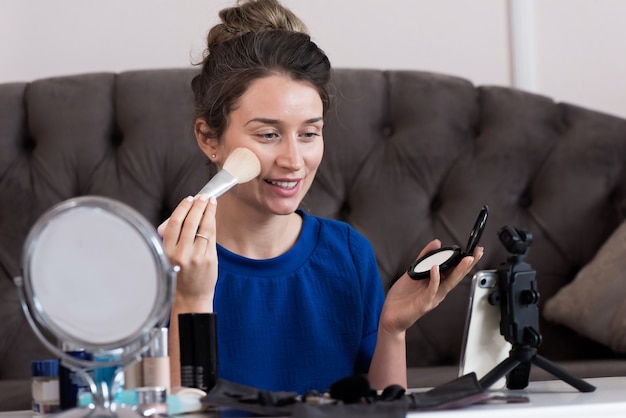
[196,75,324,215]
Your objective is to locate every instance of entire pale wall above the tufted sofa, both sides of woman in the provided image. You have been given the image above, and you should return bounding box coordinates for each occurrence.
[0,0,626,117]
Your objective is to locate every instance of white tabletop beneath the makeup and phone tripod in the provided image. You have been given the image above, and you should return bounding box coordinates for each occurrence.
[0,377,626,418]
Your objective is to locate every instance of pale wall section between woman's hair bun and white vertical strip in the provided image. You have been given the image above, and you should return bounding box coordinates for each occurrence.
[284,0,510,84]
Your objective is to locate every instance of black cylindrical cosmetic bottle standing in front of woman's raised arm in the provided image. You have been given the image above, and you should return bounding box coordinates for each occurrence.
[178,313,219,392]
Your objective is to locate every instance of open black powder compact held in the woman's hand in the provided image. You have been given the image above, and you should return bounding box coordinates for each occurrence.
[407,205,489,280]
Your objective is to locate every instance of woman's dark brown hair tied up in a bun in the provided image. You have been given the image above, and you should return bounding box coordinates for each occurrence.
[191,0,330,138]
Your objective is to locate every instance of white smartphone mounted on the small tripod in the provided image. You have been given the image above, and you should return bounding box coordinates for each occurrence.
[459,270,512,389]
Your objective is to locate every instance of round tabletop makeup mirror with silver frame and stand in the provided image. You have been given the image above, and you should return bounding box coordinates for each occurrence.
[15,196,178,417]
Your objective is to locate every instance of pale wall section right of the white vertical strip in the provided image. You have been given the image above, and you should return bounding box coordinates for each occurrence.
[535,0,626,117]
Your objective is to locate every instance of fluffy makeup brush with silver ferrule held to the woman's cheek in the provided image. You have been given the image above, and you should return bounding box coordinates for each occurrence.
[157,148,261,232]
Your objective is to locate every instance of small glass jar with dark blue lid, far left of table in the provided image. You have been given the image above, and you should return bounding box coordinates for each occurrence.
[31,359,60,415]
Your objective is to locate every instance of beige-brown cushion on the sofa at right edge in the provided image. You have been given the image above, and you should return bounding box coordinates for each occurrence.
[544,222,626,353]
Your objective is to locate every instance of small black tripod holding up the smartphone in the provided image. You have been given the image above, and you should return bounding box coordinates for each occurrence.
[480,226,596,392]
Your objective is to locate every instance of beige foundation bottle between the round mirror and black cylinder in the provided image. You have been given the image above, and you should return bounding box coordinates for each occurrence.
[142,328,170,392]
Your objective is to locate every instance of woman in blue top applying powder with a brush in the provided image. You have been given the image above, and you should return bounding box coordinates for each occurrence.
[158,0,482,393]
